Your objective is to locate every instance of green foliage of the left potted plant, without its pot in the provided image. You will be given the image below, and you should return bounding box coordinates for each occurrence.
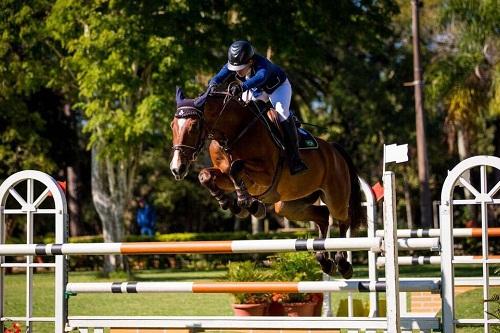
[226,261,271,304]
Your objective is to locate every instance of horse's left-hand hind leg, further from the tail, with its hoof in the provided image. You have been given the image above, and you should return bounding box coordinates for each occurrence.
[274,195,337,275]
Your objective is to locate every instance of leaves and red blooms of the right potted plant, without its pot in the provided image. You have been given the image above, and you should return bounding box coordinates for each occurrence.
[270,252,323,303]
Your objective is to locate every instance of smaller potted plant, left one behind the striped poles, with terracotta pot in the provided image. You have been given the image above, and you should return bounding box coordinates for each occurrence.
[226,261,271,316]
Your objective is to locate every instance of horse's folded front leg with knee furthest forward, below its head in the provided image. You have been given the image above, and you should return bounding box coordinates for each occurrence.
[198,168,249,218]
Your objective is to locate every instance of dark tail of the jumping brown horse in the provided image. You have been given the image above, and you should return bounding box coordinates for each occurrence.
[332,142,365,233]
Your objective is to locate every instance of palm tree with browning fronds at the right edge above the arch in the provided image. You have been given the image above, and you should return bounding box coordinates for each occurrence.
[429,0,500,159]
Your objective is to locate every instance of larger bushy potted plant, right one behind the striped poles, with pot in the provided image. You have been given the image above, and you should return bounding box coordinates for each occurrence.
[268,252,323,317]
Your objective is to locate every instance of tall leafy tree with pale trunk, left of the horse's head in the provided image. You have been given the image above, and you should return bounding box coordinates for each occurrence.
[48,0,231,270]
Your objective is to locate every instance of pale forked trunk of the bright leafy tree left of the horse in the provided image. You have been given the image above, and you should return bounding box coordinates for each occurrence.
[92,145,136,274]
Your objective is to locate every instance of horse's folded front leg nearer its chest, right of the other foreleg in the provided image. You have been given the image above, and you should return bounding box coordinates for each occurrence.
[229,160,266,219]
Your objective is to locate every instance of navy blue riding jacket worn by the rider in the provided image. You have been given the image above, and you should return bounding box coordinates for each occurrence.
[210,54,287,94]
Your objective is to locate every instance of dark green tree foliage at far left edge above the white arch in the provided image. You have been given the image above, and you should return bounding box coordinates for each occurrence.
[0,0,55,179]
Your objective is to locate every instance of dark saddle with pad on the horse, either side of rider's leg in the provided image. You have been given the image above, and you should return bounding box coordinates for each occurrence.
[252,100,319,150]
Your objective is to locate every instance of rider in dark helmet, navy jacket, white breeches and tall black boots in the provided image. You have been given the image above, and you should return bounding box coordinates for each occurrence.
[209,40,307,175]
